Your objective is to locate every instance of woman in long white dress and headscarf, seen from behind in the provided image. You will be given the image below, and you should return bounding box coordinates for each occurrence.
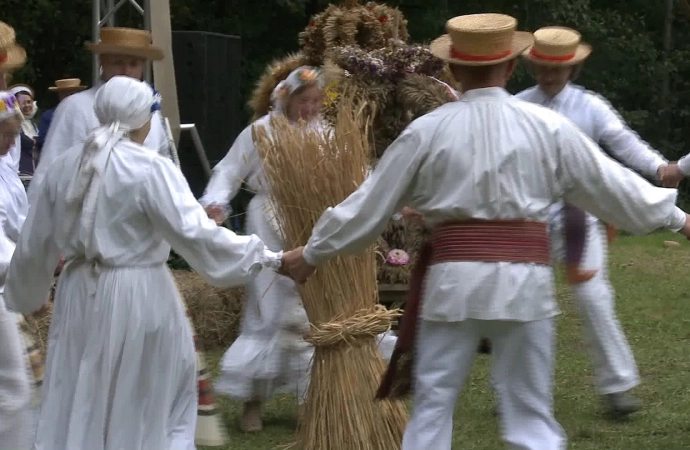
[5,77,288,450]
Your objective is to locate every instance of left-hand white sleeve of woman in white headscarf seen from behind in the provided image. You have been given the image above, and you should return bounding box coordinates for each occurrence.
[5,172,60,314]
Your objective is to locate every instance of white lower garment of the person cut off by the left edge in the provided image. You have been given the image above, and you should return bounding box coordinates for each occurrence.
[0,294,32,450]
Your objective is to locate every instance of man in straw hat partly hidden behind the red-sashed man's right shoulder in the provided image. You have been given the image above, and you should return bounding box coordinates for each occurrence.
[516,27,667,415]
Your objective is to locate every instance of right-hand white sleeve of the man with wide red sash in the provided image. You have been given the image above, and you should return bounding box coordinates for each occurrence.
[557,120,685,234]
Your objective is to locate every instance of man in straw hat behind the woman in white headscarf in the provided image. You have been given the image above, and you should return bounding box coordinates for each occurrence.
[28,27,170,208]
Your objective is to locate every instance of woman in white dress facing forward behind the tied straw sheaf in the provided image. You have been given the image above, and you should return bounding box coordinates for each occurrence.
[200,66,395,432]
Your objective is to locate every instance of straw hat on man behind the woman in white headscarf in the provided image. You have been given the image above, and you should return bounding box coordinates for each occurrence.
[85,27,165,61]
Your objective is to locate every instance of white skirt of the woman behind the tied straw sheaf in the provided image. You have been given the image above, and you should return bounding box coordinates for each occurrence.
[215,195,396,403]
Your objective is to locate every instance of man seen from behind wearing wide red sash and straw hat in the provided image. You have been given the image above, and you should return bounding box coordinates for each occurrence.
[278,14,690,450]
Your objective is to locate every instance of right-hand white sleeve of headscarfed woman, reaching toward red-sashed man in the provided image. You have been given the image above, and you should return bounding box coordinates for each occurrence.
[141,158,282,287]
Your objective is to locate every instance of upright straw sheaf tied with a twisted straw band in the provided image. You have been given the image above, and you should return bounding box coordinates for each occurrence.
[254,96,407,450]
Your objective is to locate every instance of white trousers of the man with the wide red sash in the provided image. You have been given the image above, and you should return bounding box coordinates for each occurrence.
[402,319,566,450]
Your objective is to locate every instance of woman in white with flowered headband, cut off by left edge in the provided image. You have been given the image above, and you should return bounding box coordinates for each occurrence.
[0,91,31,450]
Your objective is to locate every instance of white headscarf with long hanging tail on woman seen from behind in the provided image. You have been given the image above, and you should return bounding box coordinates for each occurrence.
[65,76,160,257]
